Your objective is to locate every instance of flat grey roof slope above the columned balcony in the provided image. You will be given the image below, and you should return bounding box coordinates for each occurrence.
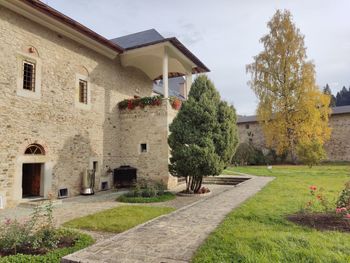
[110,28,164,49]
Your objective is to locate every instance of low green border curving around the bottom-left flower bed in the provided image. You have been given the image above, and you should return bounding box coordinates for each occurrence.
[0,230,94,263]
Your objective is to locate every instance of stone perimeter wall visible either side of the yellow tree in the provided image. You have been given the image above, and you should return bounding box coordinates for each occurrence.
[237,105,350,161]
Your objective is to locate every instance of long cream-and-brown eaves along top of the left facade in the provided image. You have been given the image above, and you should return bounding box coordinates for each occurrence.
[0,0,123,59]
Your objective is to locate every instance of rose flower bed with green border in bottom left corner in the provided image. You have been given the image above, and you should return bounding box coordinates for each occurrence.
[0,201,94,263]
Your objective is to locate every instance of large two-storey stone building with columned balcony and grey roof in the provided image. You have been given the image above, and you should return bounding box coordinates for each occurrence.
[0,0,209,208]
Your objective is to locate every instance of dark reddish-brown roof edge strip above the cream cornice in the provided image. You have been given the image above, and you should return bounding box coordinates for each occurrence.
[20,0,123,53]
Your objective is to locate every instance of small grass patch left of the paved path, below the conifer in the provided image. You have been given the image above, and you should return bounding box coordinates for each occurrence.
[64,206,175,233]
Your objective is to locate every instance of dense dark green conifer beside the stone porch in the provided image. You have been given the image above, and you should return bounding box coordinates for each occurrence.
[168,75,238,193]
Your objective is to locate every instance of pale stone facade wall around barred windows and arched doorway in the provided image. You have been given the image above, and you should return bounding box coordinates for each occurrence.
[0,7,153,206]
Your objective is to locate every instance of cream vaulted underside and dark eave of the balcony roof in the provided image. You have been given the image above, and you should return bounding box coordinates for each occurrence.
[121,38,209,80]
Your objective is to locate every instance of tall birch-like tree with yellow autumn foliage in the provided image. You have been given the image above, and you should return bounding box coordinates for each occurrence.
[247,10,331,162]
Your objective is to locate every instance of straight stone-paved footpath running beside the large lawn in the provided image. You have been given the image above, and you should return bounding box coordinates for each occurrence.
[62,177,274,263]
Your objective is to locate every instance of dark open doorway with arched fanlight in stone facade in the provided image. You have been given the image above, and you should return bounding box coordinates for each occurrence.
[22,144,45,198]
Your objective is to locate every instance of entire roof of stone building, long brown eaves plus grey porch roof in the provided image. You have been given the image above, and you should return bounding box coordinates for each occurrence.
[7,0,210,73]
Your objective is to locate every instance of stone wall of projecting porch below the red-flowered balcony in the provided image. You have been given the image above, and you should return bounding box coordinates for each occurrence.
[119,100,177,188]
